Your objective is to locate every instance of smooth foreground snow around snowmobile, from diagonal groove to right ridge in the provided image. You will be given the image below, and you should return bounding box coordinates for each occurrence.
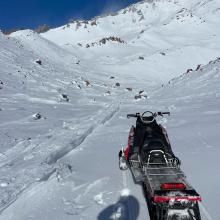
[0,56,220,220]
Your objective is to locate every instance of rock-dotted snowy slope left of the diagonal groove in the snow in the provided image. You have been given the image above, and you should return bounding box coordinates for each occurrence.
[0,30,128,210]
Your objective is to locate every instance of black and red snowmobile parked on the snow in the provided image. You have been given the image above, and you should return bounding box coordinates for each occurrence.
[119,111,201,220]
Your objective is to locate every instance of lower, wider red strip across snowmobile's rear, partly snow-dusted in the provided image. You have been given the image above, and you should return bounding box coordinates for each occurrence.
[154,196,202,203]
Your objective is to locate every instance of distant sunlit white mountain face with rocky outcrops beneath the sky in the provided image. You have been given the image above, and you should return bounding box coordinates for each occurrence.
[42,0,220,84]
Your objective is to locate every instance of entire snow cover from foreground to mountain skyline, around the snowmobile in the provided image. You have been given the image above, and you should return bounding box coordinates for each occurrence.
[0,0,220,220]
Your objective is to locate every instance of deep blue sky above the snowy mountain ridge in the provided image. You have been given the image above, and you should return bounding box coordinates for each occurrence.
[0,0,140,30]
